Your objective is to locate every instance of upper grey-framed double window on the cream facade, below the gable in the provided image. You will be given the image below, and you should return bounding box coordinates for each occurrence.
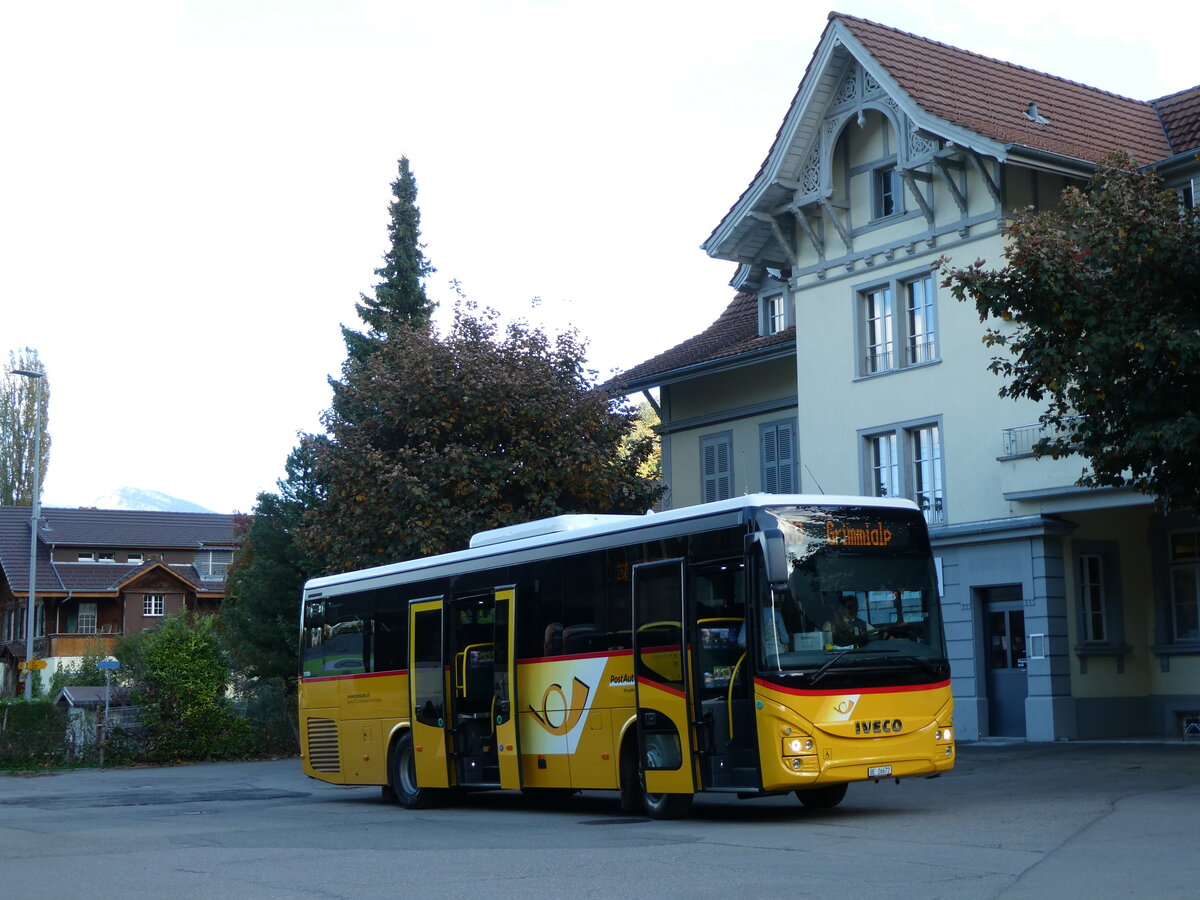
[854,269,940,377]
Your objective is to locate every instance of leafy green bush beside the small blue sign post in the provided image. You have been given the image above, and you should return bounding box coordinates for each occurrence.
[114,612,252,762]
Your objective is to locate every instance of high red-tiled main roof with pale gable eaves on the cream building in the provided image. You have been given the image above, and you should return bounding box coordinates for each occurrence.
[702,12,1200,265]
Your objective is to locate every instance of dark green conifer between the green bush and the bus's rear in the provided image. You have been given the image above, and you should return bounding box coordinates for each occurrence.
[221,443,322,683]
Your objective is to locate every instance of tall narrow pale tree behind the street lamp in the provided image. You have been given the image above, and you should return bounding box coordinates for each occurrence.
[0,347,50,506]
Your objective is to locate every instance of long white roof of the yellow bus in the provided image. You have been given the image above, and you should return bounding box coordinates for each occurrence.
[304,493,917,595]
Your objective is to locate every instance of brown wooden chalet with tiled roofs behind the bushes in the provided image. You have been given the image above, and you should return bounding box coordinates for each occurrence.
[0,506,238,695]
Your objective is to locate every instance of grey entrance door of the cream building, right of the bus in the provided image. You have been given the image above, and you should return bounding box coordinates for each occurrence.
[983,586,1028,738]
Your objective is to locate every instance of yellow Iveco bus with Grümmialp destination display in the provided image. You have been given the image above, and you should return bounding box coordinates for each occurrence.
[300,494,954,818]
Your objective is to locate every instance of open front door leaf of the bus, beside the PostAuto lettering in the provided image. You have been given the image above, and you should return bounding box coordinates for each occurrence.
[632,559,696,793]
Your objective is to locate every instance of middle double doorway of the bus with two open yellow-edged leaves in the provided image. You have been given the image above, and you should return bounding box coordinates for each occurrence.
[409,588,521,788]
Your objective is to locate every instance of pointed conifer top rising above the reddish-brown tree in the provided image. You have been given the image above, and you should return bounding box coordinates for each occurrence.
[342,156,437,361]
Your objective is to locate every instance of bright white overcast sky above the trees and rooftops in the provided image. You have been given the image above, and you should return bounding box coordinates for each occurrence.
[0,0,1200,512]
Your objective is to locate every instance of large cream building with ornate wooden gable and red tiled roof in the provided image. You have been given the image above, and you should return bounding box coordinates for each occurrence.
[612,13,1200,740]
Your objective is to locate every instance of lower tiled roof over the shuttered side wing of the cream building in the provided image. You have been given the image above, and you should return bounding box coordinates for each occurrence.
[608,292,796,391]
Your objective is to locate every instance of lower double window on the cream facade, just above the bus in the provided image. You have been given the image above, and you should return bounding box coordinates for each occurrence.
[858,416,948,524]
